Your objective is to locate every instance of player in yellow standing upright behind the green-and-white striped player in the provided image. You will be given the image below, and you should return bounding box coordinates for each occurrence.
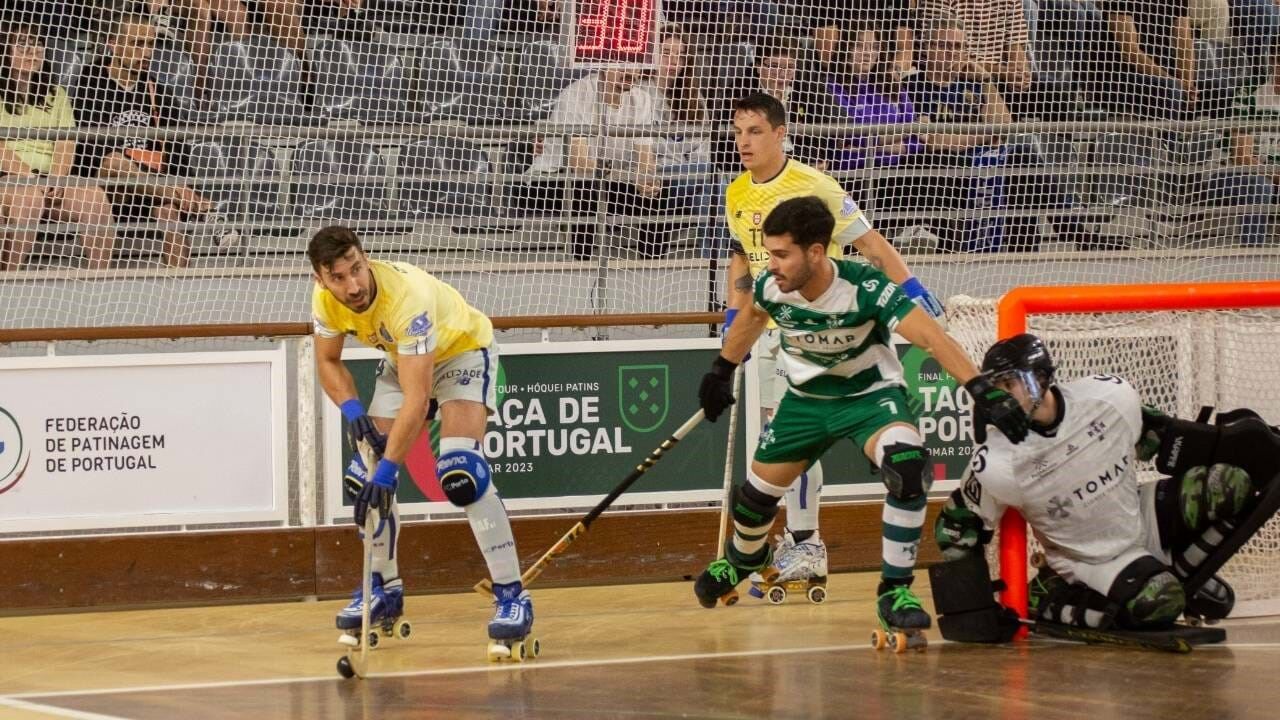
[724,92,945,596]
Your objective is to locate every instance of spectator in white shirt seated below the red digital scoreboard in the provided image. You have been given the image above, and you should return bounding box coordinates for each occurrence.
[530,69,662,260]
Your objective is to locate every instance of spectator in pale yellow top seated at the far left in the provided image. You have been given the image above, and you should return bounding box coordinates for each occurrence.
[0,19,115,270]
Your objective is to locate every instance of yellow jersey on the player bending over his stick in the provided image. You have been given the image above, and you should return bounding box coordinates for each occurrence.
[311,260,493,365]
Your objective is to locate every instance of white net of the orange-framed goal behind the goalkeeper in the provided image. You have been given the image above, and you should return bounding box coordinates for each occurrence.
[951,299,1280,615]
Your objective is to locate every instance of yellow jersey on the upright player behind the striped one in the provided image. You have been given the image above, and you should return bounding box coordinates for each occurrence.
[724,158,872,278]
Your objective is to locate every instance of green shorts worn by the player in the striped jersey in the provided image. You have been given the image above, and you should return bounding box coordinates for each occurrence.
[755,386,920,464]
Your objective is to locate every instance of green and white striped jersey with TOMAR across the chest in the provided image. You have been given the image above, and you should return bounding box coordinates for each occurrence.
[755,259,915,398]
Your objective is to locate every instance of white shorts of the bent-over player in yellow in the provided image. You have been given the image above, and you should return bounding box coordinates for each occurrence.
[369,343,498,418]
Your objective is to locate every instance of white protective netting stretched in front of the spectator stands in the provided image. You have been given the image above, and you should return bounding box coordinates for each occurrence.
[0,0,1280,327]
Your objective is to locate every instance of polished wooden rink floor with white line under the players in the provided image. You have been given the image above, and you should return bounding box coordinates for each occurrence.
[0,575,1280,720]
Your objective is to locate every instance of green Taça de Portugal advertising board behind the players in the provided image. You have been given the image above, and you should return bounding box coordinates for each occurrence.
[325,340,972,519]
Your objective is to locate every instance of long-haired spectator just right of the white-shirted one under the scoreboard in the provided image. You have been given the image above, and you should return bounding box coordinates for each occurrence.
[641,24,727,250]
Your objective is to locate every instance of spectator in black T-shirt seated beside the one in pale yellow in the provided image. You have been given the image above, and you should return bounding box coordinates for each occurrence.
[76,14,212,268]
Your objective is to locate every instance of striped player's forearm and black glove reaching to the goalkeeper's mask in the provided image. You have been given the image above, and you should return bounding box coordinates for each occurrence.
[896,307,1028,443]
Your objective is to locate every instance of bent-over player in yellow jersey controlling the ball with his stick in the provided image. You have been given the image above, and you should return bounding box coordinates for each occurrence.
[307,227,534,657]
